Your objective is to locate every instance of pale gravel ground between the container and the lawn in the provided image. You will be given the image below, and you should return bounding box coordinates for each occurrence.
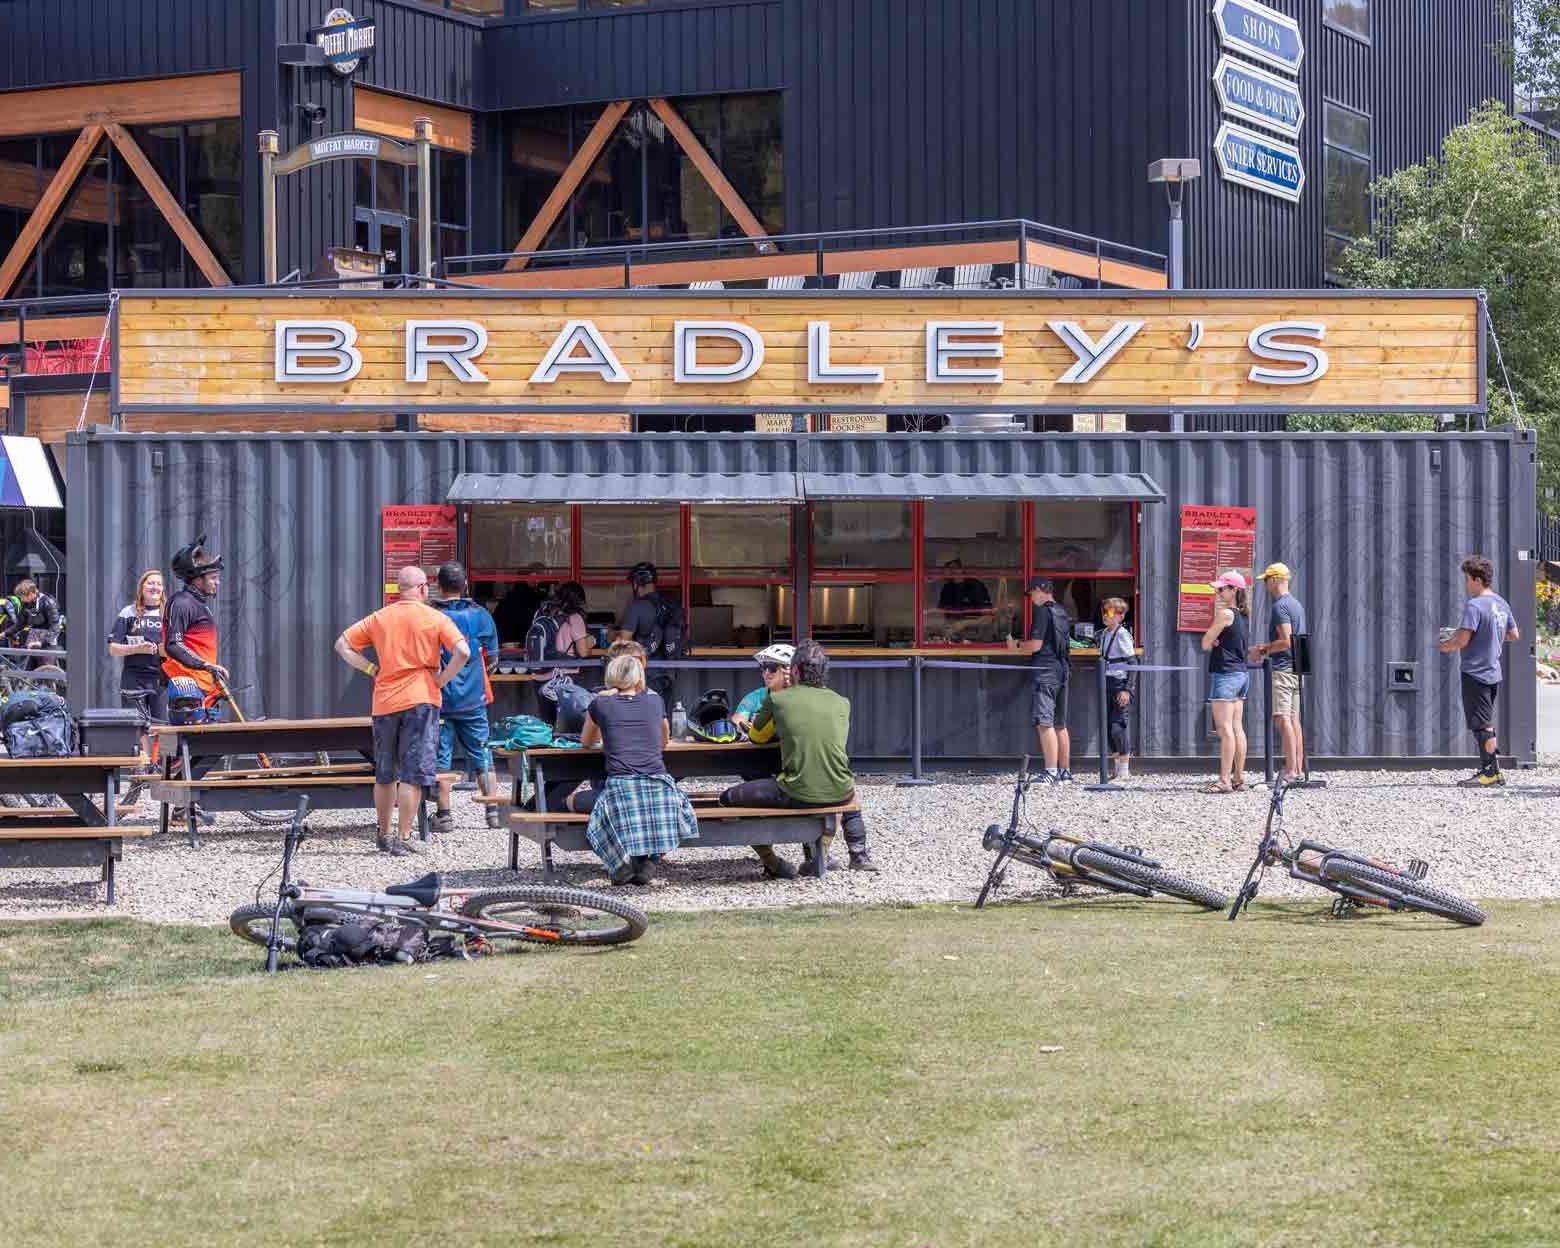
[0,755,1560,924]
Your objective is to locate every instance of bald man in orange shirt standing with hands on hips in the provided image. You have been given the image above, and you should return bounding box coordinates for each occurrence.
[335,568,471,853]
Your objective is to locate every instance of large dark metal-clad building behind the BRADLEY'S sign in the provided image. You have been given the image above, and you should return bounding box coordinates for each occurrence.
[0,0,1512,298]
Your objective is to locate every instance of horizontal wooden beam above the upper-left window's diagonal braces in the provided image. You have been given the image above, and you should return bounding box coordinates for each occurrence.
[0,73,239,139]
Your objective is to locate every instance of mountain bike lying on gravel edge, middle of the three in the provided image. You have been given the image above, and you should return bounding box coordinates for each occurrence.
[975,755,1229,909]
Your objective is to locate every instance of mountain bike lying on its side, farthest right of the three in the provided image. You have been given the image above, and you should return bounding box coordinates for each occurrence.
[1229,780,1484,927]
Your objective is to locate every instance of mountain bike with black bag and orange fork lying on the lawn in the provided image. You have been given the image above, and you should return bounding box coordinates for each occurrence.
[228,797,649,970]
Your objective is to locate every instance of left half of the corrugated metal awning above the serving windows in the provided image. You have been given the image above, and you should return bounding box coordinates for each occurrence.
[448,473,803,504]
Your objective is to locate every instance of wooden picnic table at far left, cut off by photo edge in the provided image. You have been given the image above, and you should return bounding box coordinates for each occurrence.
[0,755,151,905]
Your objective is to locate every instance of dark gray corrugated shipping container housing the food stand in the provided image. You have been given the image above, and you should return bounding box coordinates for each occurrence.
[67,431,1537,761]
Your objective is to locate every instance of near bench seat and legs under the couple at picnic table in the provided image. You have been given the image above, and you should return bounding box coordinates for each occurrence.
[509,794,861,883]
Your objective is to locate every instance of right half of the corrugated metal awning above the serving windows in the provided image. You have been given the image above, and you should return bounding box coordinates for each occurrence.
[802,473,1165,502]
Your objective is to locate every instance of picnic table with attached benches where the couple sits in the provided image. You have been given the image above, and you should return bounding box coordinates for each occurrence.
[495,741,861,881]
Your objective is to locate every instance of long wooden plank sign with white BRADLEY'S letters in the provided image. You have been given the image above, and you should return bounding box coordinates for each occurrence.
[117,292,1484,412]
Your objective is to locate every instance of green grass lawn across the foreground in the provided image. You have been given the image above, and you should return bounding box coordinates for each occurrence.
[0,899,1560,1248]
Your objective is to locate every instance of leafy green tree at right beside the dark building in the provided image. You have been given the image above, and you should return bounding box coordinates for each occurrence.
[1340,103,1560,499]
